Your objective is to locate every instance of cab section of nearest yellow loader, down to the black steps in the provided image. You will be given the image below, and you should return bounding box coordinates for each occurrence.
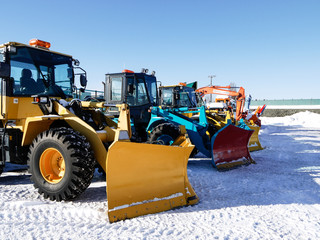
[0,39,86,167]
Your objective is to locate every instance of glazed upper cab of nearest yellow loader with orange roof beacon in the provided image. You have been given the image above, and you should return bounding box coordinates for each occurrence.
[0,39,86,98]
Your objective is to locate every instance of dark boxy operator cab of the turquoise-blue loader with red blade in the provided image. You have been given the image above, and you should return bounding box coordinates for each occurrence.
[104,69,158,141]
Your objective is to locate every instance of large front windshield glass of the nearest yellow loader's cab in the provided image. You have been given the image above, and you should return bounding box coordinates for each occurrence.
[10,47,73,97]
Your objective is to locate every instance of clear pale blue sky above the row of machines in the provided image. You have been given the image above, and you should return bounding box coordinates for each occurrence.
[0,0,320,99]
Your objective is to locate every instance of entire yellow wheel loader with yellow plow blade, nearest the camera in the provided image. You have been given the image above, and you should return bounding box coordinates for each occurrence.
[0,39,198,222]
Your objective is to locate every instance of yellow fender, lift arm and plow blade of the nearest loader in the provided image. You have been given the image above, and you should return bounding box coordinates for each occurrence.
[18,102,199,222]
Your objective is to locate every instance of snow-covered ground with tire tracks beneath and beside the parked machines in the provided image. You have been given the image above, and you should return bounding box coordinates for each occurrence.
[0,112,320,240]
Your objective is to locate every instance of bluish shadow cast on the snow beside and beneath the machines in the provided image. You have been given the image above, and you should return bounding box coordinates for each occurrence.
[0,125,320,219]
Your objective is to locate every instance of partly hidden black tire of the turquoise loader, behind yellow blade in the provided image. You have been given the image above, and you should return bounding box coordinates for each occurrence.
[149,123,180,145]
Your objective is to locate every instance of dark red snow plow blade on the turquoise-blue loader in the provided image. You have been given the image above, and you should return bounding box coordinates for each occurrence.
[211,124,255,169]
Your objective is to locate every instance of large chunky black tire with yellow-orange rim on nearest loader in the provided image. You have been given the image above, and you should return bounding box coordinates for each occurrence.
[28,127,95,201]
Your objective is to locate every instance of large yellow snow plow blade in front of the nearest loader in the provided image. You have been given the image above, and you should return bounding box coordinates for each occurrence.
[106,139,199,222]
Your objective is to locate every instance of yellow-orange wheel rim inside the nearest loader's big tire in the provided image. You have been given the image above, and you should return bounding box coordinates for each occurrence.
[39,148,65,183]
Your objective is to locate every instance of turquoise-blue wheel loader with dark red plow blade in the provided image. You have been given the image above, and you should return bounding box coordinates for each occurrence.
[104,69,254,169]
